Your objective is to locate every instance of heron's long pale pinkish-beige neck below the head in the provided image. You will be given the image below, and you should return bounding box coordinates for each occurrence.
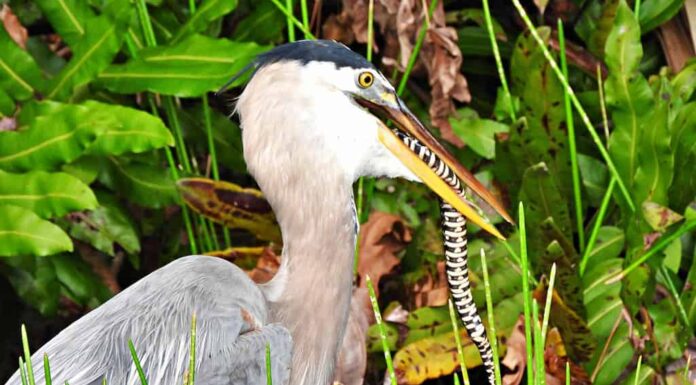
[267,174,357,385]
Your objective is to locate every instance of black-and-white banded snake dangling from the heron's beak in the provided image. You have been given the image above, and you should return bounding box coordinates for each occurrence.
[395,131,495,385]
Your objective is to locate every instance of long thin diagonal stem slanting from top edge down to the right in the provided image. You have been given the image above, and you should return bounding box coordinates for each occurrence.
[512,0,636,211]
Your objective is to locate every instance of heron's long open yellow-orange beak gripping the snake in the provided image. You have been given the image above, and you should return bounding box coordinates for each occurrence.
[360,95,513,239]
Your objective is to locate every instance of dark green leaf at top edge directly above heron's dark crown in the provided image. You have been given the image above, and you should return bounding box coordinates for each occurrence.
[231,1,287,44]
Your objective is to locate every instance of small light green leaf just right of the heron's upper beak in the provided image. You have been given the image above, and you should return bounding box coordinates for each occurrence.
[450,108,509,159]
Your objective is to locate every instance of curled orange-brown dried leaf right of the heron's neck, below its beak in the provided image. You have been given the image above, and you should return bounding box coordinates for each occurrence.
[358,212,411,295]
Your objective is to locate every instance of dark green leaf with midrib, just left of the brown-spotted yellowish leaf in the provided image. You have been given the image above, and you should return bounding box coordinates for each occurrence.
[99,157,178,208]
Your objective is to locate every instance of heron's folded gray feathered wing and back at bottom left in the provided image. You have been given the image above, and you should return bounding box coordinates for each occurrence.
[6,256,291,385]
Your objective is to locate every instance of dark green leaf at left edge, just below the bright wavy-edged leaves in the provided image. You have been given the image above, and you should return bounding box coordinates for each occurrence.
[3,255,60,316]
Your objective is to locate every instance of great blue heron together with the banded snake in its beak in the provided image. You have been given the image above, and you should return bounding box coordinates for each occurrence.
[7,41,507,385]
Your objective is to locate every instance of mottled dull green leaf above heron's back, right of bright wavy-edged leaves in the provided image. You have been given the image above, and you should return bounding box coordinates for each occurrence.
[62,193,140,257]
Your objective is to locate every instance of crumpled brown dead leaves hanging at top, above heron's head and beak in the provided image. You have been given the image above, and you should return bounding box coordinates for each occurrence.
[323,0,471,147]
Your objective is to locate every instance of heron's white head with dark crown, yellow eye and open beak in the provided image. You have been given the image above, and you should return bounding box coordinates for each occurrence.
[228,40,510,238]
